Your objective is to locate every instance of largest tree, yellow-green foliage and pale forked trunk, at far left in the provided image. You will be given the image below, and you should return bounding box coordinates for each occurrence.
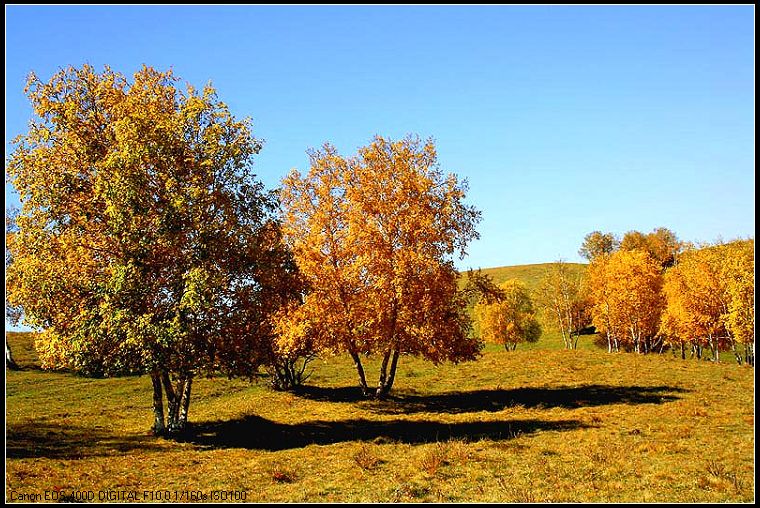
[7,65,298,433]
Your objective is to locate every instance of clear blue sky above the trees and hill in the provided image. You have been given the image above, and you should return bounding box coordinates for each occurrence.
[5,6,755,268]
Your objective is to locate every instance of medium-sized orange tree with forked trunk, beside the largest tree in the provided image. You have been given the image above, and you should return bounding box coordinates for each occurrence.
[278,136,481,397]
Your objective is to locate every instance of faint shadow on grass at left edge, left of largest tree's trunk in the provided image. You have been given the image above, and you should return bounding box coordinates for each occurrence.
[5,421,161,459]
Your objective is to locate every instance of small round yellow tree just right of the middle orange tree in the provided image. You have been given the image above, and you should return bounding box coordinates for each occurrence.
[475,280,541,351]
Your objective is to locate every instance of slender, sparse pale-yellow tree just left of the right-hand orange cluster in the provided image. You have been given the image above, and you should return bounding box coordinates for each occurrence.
[538,260,589,349]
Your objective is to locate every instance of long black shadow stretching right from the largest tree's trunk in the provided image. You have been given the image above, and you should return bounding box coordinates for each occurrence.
[183,415,588,451]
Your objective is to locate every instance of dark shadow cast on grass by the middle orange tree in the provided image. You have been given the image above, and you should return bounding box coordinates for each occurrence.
[297,385,688,414]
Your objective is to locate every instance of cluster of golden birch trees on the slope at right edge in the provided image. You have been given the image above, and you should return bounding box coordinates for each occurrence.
[580,228,755,365]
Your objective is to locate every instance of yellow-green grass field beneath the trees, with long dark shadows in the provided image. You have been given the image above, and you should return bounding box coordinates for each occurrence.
[6,328,755,502]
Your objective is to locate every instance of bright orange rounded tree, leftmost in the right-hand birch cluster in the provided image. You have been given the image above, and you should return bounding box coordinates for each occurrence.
[586,250,664,353]
